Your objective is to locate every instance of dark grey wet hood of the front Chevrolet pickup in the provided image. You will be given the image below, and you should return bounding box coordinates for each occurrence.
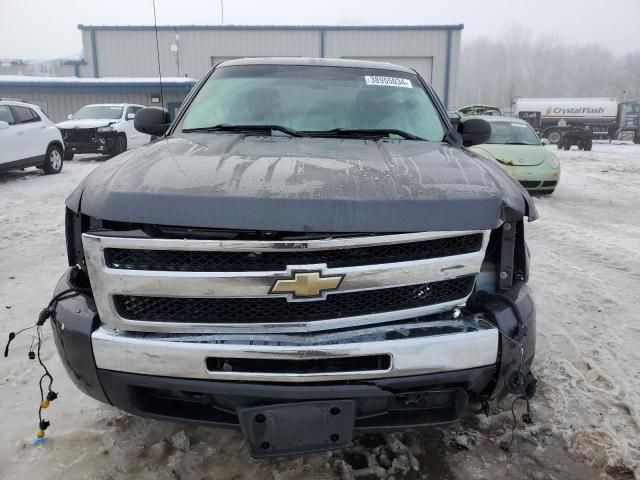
[67,134,537,233]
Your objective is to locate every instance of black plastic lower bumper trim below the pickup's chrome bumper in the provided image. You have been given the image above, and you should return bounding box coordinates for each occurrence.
[98,366,496,431]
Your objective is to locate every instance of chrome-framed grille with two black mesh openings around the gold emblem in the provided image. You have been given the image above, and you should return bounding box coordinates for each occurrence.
[83,231,489,333]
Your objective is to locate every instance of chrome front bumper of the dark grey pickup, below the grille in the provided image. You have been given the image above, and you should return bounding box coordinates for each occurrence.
[92,320,499,383]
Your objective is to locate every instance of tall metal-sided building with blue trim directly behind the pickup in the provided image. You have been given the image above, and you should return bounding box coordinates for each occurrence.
[77,25,463,105]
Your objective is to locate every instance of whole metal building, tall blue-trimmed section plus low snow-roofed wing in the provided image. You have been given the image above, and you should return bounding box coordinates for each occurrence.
[0,25,463,122]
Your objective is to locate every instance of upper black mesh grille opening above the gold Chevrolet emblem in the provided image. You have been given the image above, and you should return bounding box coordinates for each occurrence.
[104,233,482,272]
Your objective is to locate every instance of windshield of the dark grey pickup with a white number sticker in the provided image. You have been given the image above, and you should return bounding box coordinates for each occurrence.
[178,65,445,141]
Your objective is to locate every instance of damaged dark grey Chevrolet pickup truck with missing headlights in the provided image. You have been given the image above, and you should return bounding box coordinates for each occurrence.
[52,58,537,456]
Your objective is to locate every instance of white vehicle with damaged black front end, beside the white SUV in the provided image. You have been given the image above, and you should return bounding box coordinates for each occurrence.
[56,103,150,160]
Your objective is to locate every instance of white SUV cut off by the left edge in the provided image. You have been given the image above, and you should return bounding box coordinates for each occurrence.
[0,98,64,173]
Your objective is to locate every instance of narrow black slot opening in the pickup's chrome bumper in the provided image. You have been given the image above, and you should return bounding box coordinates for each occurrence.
[206,354,391,374]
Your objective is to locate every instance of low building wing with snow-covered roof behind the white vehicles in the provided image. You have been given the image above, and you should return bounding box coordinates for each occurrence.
[0,75,195,122]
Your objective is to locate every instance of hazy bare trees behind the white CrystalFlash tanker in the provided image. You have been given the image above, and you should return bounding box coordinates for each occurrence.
[456,25,640,110]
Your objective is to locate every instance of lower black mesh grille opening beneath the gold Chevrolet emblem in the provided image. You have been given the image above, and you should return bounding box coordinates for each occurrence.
[113,275,475,324]
